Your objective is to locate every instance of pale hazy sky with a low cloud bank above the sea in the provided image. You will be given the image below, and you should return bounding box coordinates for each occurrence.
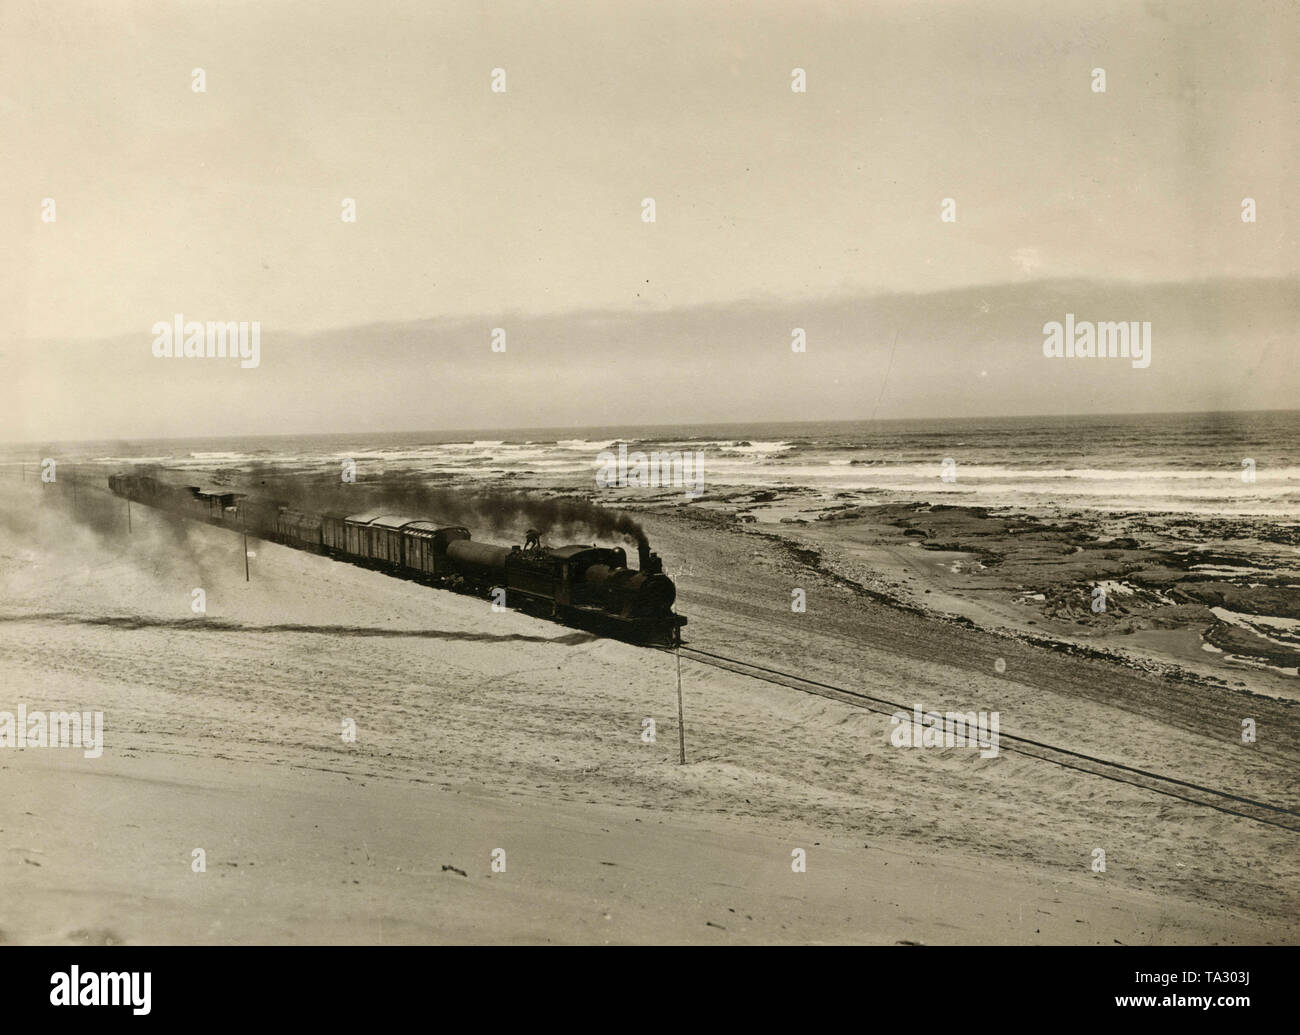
[0,0,1300,438]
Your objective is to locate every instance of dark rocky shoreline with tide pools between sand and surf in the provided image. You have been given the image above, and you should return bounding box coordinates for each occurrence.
[611,486,1300,698]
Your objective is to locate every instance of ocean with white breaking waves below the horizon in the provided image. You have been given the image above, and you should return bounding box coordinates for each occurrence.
[10,411,1300,520]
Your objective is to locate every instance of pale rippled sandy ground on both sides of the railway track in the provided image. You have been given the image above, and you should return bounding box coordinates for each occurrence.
[0,484,1300,944]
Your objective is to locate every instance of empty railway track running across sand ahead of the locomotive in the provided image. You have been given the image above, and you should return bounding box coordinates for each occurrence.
[659,644,1300,833]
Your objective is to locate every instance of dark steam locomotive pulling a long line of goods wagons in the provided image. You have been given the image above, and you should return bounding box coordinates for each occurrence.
[108,473,686,642]
